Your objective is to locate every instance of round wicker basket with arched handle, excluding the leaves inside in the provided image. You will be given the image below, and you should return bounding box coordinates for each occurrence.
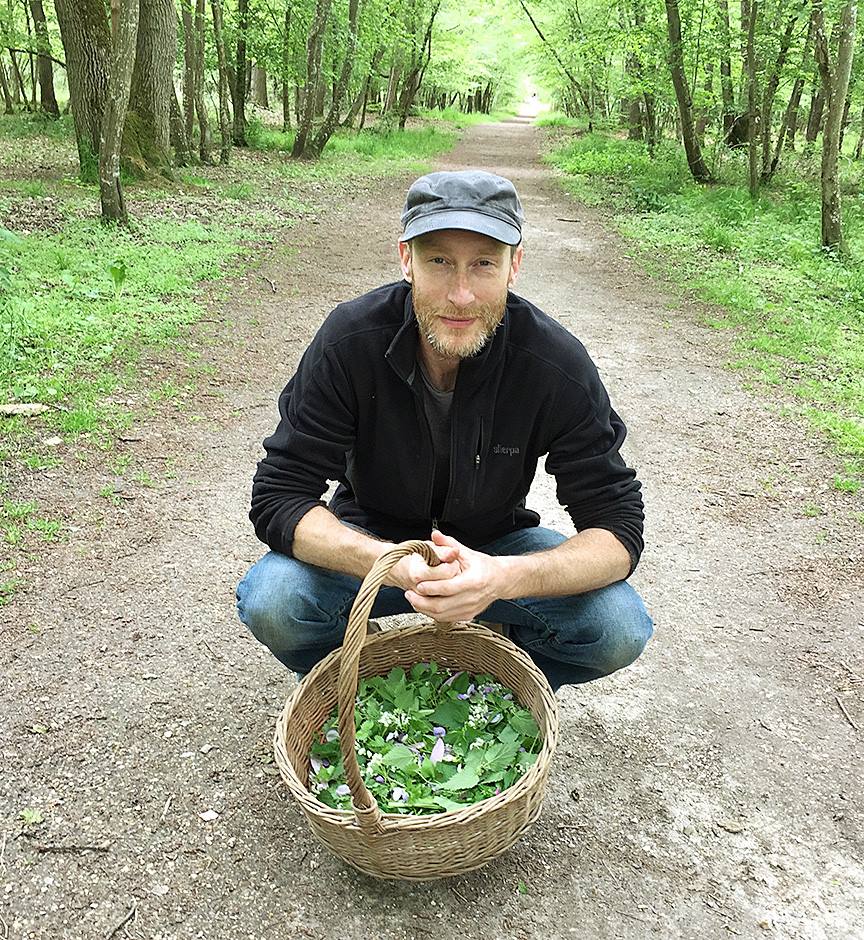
[274,541,558,881]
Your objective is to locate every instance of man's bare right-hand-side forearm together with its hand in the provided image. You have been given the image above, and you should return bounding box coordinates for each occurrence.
[405,529,631,621]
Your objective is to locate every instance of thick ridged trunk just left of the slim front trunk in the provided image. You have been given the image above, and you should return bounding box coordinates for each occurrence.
[54,0,111,182]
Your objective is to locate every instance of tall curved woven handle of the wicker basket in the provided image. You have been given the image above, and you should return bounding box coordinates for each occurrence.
[338,539,452,834]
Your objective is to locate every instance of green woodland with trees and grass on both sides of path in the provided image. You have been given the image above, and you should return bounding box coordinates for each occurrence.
[0,0,864,597]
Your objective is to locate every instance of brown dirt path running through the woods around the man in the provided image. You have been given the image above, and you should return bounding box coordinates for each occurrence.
[0,122,864,940]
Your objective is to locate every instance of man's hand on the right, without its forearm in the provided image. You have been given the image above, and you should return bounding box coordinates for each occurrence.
[405,529,502,623]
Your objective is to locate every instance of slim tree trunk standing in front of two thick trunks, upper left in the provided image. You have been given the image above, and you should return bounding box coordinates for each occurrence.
[99,0,139,225]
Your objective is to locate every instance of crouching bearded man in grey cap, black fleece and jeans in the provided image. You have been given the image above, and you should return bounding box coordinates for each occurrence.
[237,170,652,689]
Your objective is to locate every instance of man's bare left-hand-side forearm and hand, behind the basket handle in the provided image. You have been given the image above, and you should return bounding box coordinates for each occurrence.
[293,506,460,591]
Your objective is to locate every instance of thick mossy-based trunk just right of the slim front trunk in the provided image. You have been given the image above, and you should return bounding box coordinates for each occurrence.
[123,0,177,178]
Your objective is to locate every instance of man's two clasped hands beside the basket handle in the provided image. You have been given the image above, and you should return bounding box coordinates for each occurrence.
[387,529,501,623]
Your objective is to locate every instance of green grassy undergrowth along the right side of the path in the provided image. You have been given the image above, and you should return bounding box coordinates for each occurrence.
[547,133,864,491]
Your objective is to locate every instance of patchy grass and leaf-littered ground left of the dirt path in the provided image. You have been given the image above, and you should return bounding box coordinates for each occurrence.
[0,103,472,606]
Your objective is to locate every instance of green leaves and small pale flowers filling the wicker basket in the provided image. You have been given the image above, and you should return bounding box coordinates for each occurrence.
[309,663,541,814]
